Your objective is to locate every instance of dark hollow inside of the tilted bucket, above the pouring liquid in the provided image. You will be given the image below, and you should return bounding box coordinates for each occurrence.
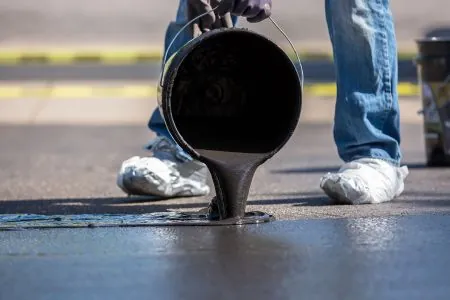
[169,30,301,153]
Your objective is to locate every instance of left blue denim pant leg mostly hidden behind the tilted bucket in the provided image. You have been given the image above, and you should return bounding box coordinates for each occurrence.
[148,0,237,140]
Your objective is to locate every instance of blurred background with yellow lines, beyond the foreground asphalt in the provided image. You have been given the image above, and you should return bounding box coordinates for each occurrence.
[0,0,450,126]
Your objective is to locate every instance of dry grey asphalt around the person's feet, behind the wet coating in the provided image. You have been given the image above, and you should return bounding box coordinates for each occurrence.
[0,123,450,220]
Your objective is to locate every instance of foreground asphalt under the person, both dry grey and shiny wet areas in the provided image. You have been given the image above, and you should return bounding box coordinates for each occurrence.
[0,122,450,300]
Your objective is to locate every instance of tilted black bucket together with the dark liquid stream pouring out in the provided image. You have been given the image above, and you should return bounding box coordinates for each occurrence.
[158,28,302,219]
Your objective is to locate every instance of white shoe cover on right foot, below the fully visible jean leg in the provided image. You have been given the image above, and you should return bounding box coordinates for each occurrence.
[320,158,409,204]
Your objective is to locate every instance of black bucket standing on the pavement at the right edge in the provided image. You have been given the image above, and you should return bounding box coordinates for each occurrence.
[417,38,450,167]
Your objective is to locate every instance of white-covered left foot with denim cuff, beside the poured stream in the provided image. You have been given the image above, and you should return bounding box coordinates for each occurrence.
[117,137,210,197]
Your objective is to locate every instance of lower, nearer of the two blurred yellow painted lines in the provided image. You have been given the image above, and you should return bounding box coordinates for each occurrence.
[0,83,419,100]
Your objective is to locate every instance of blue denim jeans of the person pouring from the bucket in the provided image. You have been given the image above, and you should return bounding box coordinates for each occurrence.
[148,0,401,165]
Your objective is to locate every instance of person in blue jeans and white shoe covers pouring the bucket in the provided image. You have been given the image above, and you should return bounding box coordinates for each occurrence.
[117,0,408,204]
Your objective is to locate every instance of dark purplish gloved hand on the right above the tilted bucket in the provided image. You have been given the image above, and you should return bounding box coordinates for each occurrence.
[217,0,272,23]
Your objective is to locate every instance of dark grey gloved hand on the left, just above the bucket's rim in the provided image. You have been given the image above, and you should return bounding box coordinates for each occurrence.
[187,0,233,37]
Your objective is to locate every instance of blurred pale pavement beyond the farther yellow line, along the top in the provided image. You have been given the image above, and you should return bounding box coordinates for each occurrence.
[0,0,449,51]
